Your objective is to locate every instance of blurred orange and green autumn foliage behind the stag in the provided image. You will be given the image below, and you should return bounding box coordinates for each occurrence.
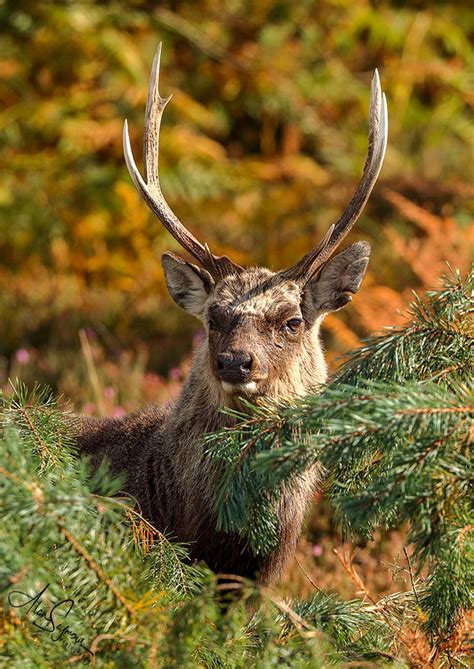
[0,0,474,591]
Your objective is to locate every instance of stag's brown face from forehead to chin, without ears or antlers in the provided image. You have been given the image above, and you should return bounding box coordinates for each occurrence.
[205,269,304,395]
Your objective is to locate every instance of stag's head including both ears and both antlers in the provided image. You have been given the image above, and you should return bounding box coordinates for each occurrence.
[123,44,388,399]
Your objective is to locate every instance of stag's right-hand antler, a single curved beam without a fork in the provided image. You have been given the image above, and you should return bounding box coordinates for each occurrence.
[281,70,388,284]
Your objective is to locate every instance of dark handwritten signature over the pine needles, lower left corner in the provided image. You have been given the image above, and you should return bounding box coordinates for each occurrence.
[8,583,94,656]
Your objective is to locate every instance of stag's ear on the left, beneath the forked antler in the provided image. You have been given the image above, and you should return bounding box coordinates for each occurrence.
[161,253,214,318]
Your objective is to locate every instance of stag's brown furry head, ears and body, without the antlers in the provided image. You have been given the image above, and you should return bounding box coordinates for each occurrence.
[79,242,369,583]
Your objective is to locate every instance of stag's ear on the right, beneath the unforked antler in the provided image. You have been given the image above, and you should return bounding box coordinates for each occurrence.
[304,242,370,318]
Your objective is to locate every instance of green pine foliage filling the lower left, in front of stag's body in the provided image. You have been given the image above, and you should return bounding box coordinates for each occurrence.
[0,384,390,669]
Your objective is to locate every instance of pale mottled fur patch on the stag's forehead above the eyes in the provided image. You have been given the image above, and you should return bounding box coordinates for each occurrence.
[210,267,301,315]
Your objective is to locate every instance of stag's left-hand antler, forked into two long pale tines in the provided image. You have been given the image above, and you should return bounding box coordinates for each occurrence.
[123,42,242,279]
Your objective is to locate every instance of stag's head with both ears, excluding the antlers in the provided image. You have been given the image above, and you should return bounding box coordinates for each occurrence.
[162,242,370,397]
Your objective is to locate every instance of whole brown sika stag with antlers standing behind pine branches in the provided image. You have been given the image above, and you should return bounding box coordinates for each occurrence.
[79,45,387,583]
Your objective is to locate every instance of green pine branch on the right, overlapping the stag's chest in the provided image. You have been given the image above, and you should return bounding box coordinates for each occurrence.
[207,274,474,639]
